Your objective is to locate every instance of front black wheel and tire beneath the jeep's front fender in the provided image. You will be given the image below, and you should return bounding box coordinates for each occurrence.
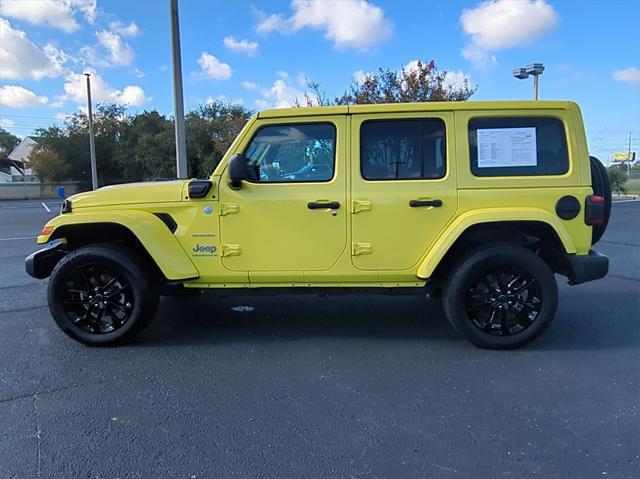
[47,244,158,345]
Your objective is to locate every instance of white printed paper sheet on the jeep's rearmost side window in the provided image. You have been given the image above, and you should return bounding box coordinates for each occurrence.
[477,127,538,168]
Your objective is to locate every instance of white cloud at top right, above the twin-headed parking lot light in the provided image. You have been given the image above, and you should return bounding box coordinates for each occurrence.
[460,0,558,66]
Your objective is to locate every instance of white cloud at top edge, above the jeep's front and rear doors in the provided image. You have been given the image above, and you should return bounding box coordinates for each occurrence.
[256,0,392,50]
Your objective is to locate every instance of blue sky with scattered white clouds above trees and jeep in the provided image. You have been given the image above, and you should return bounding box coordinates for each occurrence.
[0,0,640,161]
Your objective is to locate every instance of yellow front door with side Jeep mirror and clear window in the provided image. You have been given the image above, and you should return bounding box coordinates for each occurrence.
[220,116,348,281]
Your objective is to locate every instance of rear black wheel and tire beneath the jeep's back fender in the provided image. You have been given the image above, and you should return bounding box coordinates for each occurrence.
[443,243,558,349]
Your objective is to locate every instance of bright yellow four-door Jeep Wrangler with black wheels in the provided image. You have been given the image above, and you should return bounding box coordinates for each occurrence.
[26,101,611,349]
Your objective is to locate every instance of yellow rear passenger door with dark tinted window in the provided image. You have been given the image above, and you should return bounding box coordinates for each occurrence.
[351,112,458,271]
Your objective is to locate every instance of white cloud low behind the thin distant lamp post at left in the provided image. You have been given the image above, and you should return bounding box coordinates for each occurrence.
[62,70,151,106]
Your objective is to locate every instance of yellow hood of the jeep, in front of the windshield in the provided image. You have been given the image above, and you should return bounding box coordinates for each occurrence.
[69,180,190,211]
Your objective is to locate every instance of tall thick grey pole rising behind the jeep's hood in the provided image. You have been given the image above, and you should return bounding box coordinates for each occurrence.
[170,0,188,178]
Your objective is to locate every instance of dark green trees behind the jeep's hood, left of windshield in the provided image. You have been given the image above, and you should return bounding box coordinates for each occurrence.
[36,102,251,186]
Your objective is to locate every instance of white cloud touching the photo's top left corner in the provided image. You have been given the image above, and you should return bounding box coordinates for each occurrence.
[0,0,97,33]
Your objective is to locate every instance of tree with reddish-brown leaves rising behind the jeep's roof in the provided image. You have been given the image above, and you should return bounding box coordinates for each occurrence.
[305,60,476,106]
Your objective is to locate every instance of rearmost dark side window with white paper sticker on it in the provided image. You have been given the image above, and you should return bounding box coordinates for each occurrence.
[469,117,569,176]
